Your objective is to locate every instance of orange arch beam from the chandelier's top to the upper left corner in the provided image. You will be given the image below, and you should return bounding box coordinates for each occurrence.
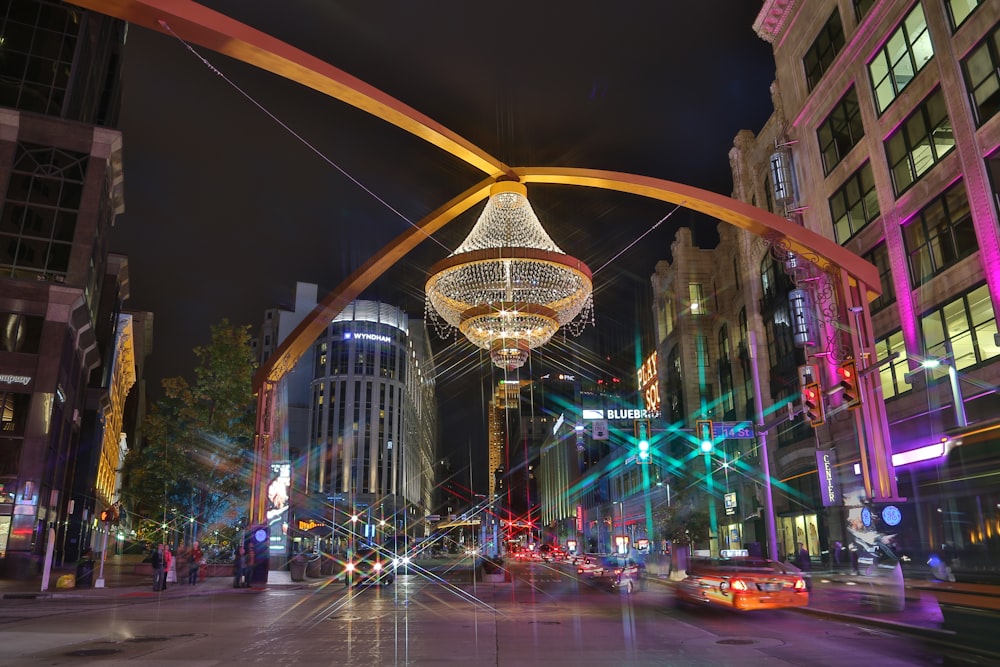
[68,0,510,177]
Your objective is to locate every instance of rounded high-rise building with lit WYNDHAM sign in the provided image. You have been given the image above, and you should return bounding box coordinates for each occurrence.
[256,290,438,562]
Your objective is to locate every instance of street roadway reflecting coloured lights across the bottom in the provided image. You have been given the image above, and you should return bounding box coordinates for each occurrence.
[0,559,991,667]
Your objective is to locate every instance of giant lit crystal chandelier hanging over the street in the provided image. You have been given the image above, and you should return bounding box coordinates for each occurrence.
[425,181,594,370]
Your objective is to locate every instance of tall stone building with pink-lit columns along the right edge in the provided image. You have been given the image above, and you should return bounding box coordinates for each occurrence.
[720,0,1000,566]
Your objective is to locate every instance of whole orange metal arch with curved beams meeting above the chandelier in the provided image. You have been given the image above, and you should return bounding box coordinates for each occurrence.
[76,0,892,521]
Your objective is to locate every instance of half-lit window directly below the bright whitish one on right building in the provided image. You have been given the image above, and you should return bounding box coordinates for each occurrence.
[885,88,955,196]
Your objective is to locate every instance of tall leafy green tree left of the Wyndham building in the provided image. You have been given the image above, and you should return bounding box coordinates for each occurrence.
[122,319,256,539]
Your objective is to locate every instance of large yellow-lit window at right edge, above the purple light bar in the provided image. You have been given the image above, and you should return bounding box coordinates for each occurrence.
[920,285,1000,370]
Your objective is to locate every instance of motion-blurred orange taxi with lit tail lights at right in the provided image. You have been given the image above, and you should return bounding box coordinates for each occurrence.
[675,556,809,612]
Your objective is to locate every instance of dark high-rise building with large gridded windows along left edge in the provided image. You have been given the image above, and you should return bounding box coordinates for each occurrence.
[0,0,134,577]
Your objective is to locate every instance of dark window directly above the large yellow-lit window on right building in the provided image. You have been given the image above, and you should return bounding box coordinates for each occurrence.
[903,182,978,287]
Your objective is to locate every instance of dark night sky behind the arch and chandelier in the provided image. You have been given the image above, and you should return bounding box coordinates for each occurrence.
[112,0,774,486]
